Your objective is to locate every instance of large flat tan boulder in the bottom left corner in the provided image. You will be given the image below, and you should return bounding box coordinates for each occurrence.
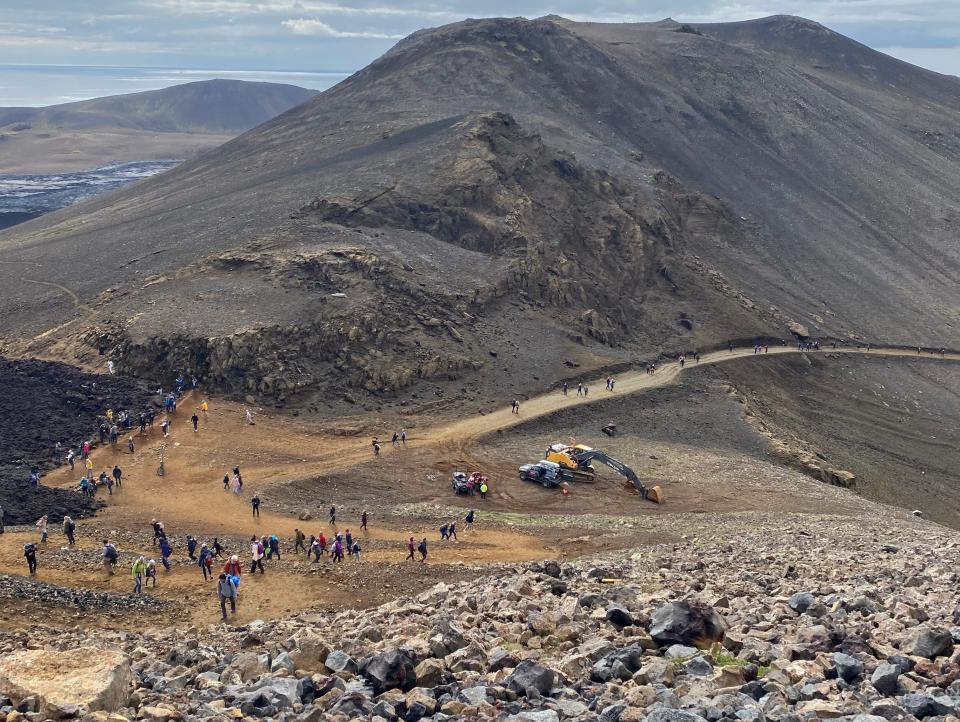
[0,647,133,717]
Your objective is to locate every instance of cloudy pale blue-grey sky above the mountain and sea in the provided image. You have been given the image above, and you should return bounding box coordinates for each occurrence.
[0,0,960,74]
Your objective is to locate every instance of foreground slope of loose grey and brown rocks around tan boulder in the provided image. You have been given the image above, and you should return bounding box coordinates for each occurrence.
[0,514,960,722]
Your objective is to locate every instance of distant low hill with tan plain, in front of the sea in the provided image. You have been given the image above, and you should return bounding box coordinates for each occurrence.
[0,80,316,173]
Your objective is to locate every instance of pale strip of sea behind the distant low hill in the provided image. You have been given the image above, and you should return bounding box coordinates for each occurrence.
[0,64,351,107]
